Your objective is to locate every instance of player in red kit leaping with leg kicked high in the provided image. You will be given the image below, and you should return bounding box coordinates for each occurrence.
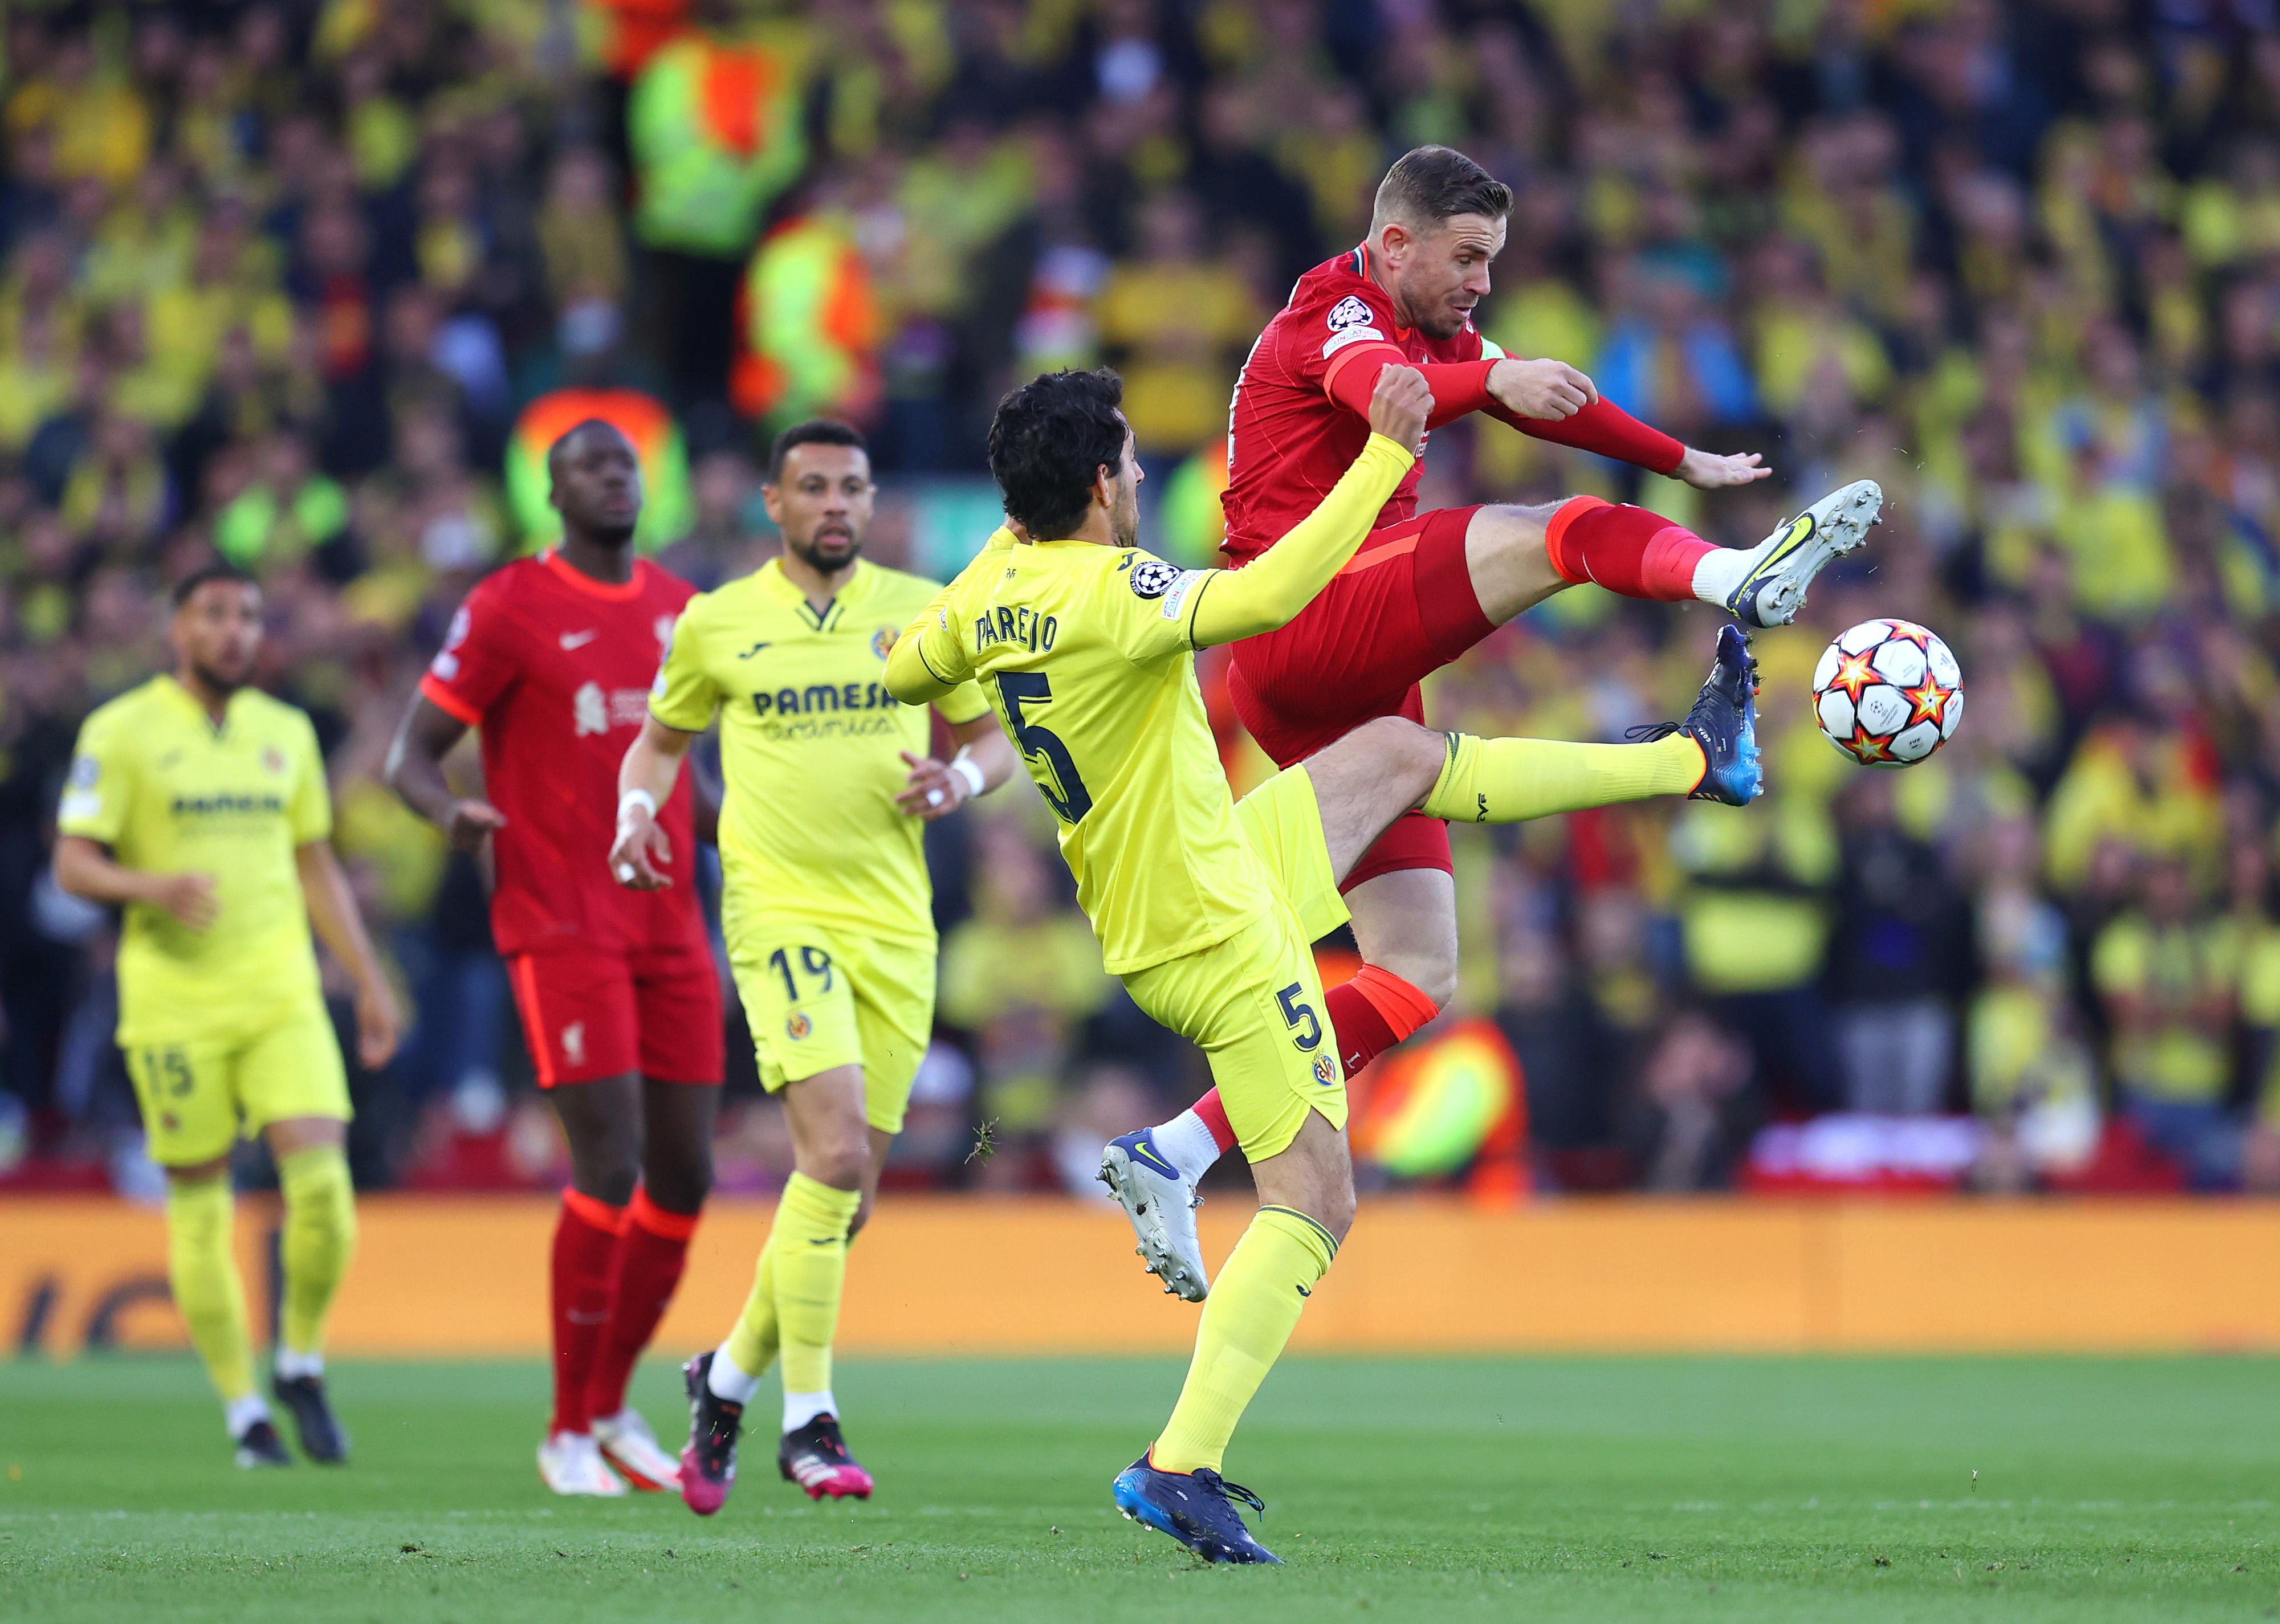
[1101,146,1883,1300]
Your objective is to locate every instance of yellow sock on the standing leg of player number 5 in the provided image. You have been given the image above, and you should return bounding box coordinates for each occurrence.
[1149,1206,1338,1471]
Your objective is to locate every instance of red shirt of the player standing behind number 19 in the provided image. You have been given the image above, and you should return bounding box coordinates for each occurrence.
[420,552,705,953]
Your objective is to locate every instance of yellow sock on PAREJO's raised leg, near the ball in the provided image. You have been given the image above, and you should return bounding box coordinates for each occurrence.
[1423,732,1703,823]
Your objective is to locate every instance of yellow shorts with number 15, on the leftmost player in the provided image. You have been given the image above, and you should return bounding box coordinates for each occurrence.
[119,1003,356,1168]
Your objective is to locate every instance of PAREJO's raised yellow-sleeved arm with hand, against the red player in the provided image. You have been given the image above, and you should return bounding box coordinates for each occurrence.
[1188,365,1432,648]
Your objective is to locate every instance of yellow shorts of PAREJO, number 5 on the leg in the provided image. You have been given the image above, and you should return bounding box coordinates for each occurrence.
[1124,766,1347,1161]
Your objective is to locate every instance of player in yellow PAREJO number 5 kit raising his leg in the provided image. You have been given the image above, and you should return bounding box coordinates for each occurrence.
[887,365,1760,1562]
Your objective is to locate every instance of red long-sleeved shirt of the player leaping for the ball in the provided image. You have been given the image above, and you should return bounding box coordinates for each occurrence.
[1220,248,1685,564]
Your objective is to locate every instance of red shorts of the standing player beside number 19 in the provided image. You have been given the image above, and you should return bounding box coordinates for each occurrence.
[506,940,727,1088]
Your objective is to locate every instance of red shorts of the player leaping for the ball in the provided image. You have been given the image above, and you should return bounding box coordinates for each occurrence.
[1227,507,1496,889]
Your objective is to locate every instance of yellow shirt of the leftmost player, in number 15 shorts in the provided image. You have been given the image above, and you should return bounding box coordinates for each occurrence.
[57,678,333,1044]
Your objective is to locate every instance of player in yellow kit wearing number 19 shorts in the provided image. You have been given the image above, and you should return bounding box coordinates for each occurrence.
[616,420,1015,1517]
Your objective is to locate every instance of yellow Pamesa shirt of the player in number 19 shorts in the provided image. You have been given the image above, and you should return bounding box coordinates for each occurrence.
[650,559,990,946]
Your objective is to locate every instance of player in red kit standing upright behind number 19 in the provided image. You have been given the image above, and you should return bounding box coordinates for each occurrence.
[390,422,725,1494]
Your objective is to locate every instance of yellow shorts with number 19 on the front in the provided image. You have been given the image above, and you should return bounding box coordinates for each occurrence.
[727,919,935,1133]
